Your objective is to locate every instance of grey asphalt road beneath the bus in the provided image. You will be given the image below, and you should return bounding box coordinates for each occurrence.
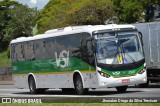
[0,84,160,98]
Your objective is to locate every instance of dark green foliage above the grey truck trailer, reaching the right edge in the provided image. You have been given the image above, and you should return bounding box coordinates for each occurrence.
[112,0,160,23]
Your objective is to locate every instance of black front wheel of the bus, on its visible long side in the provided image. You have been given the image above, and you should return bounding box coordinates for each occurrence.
[74,75,88,95]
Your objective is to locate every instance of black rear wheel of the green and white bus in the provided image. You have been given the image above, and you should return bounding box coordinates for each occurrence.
[28,76,37,94]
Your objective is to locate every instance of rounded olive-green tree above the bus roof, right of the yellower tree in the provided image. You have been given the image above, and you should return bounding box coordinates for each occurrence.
[67,0,115,25]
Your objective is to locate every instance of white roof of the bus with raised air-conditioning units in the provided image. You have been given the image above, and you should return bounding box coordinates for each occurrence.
[10,24,135,44]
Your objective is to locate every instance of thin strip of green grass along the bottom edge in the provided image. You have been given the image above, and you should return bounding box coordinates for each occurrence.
[0,103,160,106]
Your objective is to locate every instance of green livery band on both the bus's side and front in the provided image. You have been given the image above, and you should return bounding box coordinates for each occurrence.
[12,57,144,77]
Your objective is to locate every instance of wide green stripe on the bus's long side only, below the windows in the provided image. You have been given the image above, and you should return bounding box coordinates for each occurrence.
[12,57,95,74]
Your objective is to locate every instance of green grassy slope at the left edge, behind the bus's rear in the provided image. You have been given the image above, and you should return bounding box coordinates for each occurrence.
[0,51,11,68]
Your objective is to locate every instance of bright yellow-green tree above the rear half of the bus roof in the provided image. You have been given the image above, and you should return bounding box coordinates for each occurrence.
[37,0,71,33]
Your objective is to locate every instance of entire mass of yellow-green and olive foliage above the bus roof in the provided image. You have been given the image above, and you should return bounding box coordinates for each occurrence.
[37,0,115,33]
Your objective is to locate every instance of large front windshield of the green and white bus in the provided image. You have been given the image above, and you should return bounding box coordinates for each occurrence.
[94,31,144,64]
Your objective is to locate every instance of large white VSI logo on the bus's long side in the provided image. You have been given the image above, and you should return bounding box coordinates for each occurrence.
[55,50,69,68]
